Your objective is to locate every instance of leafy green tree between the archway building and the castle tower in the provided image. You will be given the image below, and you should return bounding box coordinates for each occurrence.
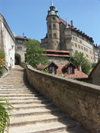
[24,39,48,68]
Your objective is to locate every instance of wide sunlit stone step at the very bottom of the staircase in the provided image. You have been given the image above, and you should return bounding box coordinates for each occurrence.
[9,120,77,133]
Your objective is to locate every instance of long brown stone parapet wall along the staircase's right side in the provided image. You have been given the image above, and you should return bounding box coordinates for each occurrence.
[23,65,100,133]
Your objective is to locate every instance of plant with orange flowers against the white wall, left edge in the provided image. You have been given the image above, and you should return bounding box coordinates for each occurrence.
[0,49,5,77]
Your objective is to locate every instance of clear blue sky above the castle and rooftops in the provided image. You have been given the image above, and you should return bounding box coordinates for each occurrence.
[0,0,100,45]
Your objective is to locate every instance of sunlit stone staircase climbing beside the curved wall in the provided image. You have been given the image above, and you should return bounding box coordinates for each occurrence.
[0,66,89,133]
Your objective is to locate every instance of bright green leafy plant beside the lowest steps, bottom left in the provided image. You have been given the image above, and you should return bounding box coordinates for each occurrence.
[0,98,13,133]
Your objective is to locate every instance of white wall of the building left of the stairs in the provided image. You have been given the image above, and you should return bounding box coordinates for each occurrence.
[0,14,15,68]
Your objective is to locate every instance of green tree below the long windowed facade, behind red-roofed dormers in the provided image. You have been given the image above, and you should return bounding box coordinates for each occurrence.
[69,52,91,74]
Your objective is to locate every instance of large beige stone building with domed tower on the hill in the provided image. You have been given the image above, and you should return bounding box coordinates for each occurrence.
[40,2,95,63]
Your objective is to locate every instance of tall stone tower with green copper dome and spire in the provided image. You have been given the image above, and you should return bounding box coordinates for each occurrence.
[46,0,60,50]
